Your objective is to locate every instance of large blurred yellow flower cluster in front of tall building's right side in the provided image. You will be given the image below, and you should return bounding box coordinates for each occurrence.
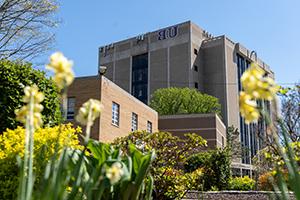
[241,63,280,101]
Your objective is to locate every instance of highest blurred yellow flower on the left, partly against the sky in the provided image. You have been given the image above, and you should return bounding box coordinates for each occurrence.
[46,52,74,89]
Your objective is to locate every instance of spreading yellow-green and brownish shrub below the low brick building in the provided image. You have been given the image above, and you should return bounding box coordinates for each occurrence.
[112,131,206,168]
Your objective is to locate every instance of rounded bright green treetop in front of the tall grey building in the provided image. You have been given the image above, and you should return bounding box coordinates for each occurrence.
[150,87,221,115]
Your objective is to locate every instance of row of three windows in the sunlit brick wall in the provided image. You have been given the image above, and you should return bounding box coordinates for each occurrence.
[111,102,152,133]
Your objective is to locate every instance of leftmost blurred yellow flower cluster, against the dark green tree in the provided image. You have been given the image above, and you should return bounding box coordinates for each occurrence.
[15,85,44,128]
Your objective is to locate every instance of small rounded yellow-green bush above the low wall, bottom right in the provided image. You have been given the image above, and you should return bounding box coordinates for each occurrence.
[229,176,255,191]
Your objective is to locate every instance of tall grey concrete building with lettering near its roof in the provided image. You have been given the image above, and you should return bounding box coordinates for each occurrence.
[99,21,274,173]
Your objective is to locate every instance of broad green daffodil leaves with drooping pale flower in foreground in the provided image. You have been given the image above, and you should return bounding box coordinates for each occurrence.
[34,140,155,200]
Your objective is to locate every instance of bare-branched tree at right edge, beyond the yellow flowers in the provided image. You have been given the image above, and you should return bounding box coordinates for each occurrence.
[281,84,300,142]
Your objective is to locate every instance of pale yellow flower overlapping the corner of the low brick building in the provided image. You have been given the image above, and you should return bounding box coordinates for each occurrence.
[76,99,103,125]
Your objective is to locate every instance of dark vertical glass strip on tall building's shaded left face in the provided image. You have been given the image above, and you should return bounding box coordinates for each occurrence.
[131,53,148,104]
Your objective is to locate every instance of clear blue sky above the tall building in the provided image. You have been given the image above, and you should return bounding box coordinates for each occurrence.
[48,0,300,84]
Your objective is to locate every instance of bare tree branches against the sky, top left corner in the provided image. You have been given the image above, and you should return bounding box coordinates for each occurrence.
[0,0,57,60]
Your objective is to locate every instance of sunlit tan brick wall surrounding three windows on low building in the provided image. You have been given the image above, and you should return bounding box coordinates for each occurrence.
[100,78,158,142]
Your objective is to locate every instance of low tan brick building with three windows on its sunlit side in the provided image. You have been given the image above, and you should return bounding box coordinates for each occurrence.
[67,76,158,142]
